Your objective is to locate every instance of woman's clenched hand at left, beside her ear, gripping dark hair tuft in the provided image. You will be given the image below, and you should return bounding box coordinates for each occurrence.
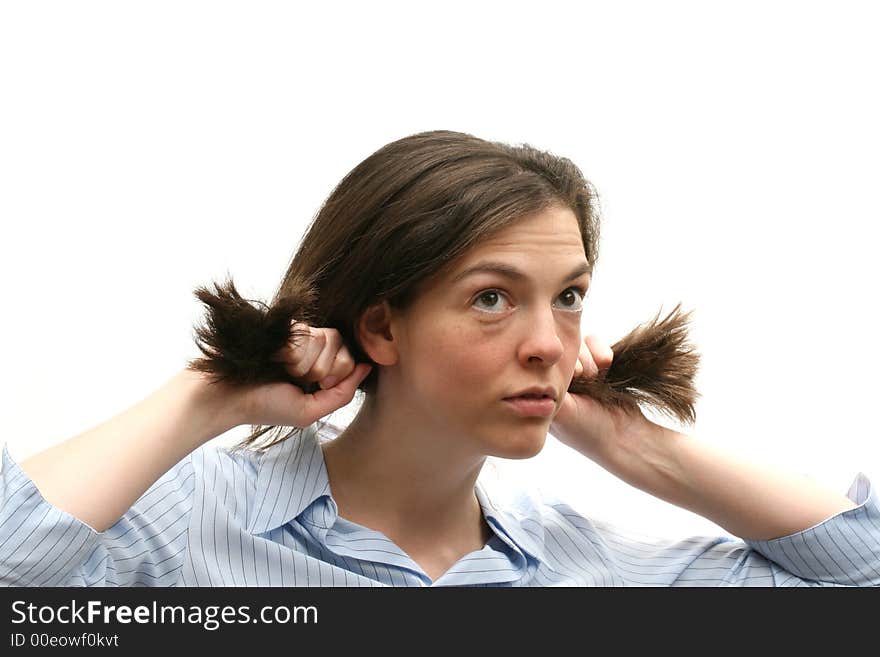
[234,322,372,427]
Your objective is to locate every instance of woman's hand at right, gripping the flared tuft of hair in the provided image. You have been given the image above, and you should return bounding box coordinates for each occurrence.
[550,335,657,467]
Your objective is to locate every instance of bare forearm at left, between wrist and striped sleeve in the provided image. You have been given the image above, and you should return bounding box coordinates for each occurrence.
[20,370,244,531]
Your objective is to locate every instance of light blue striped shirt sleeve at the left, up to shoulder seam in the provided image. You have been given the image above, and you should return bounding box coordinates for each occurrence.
[0,444,194,586]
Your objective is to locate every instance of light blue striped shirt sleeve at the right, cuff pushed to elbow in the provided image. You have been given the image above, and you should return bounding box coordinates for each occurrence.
[591,472,880,587]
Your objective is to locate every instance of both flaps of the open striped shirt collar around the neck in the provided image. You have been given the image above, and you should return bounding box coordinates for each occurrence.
[248,422,544,561]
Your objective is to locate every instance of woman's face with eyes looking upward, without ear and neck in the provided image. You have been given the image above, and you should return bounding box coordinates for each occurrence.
[390,202,590,458]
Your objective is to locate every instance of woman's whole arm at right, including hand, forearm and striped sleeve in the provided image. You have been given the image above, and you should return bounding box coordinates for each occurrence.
[551,336,880,586]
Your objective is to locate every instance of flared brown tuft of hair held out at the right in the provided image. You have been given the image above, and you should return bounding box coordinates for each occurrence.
[568,303,700,424]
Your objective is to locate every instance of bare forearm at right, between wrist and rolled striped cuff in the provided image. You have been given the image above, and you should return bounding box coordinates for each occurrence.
[603,423,855,540]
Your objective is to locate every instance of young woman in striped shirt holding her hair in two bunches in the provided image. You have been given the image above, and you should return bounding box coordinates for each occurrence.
[0,131,880,586]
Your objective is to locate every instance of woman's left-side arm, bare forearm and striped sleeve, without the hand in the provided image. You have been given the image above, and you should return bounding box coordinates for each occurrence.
[0,370,241,586]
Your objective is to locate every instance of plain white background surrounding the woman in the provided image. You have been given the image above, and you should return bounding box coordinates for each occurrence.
[0,1,880,537]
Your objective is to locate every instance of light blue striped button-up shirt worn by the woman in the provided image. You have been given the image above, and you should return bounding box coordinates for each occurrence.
[0,423,880,586]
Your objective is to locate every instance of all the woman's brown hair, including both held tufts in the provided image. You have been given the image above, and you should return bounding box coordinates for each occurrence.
[187,130,698,449]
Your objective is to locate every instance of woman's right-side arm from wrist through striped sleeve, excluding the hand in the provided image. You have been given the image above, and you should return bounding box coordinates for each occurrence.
[576,423,880,586]
